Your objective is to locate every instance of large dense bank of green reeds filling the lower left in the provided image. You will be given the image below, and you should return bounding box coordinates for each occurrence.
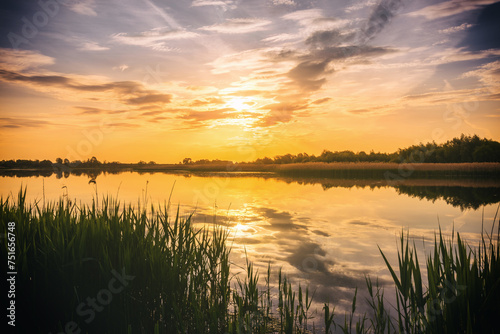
[0,189,318,333]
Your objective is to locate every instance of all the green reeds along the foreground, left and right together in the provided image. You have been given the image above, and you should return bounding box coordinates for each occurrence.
[0,189,500,333]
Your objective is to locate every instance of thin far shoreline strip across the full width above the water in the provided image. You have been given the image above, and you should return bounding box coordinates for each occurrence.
[0,162,500,183]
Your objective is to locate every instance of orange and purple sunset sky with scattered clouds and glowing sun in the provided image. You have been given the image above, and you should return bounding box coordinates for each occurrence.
[0,0,500,163]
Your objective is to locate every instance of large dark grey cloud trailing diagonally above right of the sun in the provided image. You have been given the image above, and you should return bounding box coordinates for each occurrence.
[254,4,401,127]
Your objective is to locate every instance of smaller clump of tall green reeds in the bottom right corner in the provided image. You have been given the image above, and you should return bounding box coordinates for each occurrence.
[339,210,500,334]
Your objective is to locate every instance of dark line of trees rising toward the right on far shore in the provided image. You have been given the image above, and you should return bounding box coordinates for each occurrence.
[254,135,500,164]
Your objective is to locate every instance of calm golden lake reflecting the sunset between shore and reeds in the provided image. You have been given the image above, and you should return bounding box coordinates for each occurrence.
[0,172,500,312]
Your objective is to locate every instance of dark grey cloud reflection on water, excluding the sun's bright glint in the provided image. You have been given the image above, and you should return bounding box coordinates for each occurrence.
[227,207,378,310]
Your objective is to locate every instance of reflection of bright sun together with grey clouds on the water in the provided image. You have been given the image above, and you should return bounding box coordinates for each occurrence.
[195,206,385,314]
